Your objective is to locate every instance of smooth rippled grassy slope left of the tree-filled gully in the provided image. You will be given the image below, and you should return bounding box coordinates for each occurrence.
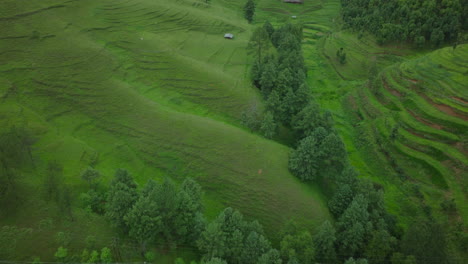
[0,0,329,260]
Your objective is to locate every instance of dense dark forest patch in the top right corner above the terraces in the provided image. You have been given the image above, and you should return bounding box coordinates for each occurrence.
[341,0,468,46]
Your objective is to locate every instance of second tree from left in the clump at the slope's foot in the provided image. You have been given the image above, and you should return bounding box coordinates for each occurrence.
[124,180,162,256]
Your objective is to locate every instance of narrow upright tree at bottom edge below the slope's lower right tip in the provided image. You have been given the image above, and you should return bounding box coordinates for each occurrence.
[314,221,336,263]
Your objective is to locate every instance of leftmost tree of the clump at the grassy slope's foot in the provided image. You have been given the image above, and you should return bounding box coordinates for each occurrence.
[105,169,138,233]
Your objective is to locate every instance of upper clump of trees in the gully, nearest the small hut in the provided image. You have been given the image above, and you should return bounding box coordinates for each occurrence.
[245,22,324,138]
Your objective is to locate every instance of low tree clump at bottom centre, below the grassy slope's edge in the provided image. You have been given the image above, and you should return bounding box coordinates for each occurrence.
[197,208,271,264]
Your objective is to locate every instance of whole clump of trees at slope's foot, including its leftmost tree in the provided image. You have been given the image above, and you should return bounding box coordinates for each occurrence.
[105,169,204,255]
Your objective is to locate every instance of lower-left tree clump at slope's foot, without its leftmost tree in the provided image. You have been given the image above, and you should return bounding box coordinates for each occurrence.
[124,176,205,254]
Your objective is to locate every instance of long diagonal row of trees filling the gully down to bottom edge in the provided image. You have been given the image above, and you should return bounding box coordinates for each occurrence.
[247,22,447,264]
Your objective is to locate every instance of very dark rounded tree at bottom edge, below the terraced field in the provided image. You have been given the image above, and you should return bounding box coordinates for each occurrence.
[401,220,448,264]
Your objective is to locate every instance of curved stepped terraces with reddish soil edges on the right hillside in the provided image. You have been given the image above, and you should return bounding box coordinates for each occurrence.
[344,45,468,222]
